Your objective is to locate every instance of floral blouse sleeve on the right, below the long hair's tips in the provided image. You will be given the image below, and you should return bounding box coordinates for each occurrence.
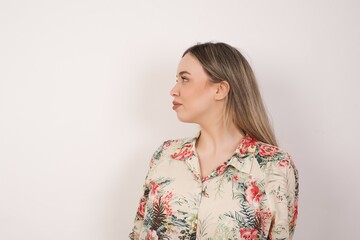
[268,153,299,240]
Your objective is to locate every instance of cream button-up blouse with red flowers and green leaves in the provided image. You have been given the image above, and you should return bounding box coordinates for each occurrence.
[129,134,299,240]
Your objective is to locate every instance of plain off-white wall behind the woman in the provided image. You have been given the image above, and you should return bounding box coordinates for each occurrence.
[0,0,360,240]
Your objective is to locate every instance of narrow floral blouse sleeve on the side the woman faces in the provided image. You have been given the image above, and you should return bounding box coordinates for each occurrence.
[129,142,166,240]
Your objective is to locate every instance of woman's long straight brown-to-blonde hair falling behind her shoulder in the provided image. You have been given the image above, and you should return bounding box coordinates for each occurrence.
[183,42,277,146]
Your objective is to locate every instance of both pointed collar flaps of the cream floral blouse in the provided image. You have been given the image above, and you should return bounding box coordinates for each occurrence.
[171,131,257,174]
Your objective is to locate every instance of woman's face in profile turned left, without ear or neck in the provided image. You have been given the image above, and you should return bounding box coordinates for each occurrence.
[170,53,216,124]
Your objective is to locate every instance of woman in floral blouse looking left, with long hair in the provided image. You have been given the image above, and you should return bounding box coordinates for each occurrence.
[130,43,298,240]
